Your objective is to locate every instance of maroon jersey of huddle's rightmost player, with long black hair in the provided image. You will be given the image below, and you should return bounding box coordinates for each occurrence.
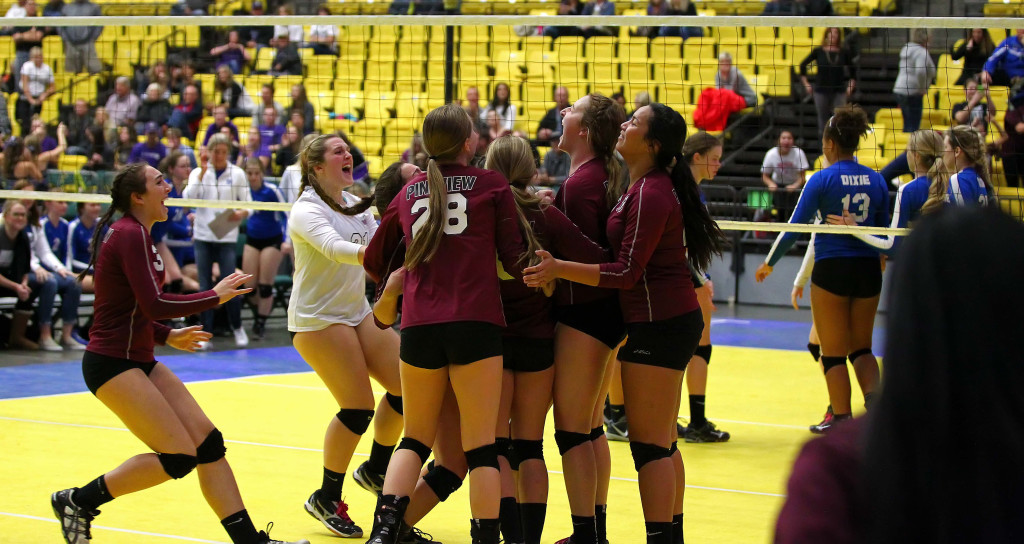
[598,168,699,323]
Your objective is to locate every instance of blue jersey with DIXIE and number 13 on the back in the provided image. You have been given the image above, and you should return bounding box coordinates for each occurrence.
[766,161,889,266]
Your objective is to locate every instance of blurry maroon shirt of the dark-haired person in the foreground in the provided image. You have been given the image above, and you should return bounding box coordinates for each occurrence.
[775,417,867,544]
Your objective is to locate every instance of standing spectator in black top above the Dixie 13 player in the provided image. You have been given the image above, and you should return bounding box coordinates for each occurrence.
[800,27,857,133]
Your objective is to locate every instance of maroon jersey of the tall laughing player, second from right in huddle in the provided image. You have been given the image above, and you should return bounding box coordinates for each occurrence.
[555,159,615,306]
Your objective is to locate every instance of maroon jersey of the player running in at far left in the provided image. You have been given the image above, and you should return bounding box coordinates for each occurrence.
[86,215,220,363]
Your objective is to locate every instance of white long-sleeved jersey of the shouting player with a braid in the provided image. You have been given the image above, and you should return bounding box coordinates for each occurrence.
[288,187,377,332]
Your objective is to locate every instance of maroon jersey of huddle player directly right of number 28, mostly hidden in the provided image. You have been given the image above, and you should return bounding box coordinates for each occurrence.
[502,206,608,338]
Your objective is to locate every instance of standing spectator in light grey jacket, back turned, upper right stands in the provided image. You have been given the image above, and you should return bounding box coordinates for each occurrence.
[893,28,937,132]
